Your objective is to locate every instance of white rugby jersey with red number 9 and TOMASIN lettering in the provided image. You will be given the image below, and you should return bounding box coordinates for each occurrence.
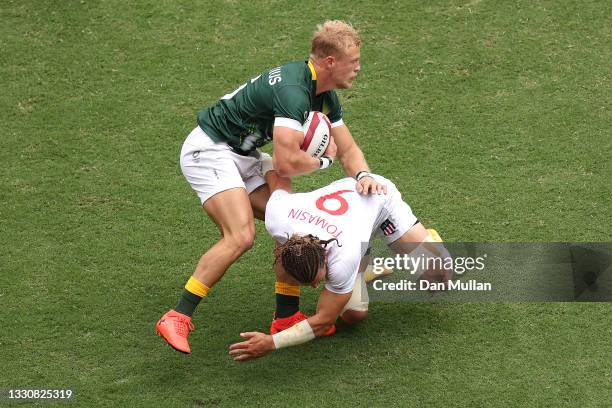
[266,176,392,294]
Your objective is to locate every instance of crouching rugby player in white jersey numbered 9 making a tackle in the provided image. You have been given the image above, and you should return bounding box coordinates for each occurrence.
[229,171,452,361]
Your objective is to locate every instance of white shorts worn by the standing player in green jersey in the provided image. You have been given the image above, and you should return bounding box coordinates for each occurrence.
[180,126,266,204]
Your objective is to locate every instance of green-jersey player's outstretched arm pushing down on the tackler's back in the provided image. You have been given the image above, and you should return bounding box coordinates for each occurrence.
[331,125,387,195]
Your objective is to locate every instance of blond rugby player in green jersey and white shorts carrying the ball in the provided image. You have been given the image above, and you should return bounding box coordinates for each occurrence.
[156,21,386,353]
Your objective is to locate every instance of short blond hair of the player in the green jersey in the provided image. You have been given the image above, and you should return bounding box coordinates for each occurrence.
[310,20,361,58]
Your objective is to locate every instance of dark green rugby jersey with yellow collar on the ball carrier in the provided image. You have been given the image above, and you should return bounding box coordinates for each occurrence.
[198,61,342,153]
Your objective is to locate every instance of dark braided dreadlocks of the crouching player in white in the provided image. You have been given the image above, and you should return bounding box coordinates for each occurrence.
[274,234,338,283]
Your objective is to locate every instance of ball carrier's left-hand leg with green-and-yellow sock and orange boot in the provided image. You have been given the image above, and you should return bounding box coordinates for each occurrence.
[156,188,255,353]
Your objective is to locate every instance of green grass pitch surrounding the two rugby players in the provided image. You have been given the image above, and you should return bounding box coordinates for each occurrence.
[0,0,612,408]
